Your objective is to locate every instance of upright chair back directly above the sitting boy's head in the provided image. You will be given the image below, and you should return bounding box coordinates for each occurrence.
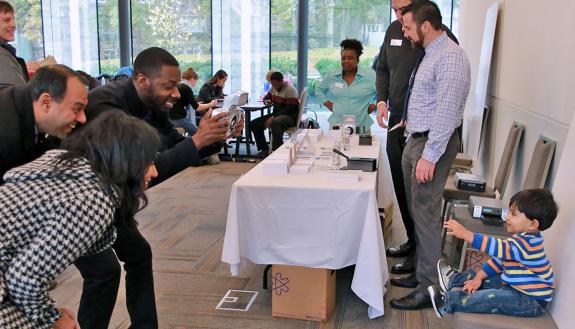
[522,136,557,190]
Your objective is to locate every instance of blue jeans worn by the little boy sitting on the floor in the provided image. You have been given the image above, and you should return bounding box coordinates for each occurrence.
[445,270,545,317]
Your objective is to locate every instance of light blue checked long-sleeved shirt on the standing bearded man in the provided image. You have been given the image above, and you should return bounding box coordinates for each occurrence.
[406,32,471,163]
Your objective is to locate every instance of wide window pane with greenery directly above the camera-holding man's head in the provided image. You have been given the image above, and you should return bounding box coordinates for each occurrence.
[131,0,212,94]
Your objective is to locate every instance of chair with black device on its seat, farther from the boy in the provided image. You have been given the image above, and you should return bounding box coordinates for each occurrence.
[441,122,524,218]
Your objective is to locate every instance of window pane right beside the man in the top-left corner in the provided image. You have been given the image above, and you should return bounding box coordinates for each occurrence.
[10,0,44,61]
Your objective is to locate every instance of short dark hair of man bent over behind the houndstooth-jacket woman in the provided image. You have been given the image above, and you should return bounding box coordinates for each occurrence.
[28,64,88,103]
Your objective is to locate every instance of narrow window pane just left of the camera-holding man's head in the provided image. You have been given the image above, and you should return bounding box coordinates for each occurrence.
[98,0,120,75]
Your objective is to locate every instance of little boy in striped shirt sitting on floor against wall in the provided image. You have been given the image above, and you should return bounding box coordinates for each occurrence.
[428,189,557,317]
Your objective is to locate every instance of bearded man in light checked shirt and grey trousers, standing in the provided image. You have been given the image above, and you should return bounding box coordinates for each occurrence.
[390,1,471,310]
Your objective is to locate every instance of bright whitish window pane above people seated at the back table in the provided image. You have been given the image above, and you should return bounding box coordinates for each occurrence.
[212,0,270,100]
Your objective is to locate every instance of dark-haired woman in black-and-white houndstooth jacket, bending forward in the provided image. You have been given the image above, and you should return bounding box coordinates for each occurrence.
[0,111,161,329]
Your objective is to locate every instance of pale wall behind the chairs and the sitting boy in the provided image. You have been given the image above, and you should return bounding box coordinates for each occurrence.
[460,0,575,328]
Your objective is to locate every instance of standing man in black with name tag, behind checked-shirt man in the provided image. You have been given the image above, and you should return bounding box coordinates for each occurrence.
[376,0,457,288]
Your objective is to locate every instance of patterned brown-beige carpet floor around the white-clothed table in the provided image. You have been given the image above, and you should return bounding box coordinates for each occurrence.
[52,162,552,329]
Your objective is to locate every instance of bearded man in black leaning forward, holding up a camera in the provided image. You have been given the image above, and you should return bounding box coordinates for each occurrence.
[75,47,243,329]
